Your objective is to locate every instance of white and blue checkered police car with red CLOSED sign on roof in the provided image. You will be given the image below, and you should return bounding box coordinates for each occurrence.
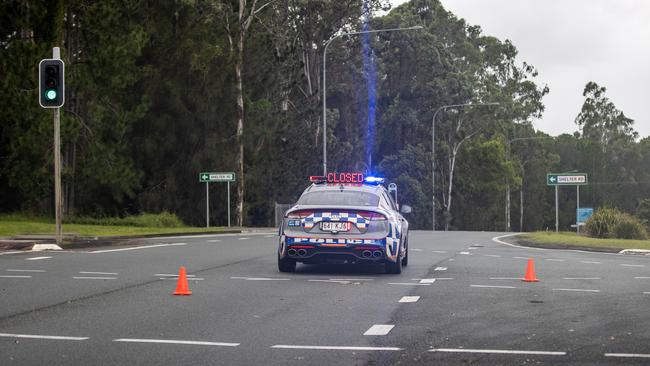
[278,173,411,274]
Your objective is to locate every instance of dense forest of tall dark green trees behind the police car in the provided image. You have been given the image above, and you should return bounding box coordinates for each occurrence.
[0,0,650,231]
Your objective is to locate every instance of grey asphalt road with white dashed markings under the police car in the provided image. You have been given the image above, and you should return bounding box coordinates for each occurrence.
[0,231,650,365]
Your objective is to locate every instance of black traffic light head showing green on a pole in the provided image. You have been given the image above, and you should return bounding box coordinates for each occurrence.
[38,59,65,108]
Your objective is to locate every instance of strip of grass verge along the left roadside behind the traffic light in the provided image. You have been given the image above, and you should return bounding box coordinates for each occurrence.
[0,214,228,237]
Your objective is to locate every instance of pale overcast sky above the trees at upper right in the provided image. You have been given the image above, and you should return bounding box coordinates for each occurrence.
[391,0,650,137]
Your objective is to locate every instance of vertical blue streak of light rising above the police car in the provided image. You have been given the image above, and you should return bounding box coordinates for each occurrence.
[361,0,377,174]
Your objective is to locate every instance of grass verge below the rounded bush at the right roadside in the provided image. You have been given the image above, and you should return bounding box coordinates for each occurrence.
[517,231,650,249]
